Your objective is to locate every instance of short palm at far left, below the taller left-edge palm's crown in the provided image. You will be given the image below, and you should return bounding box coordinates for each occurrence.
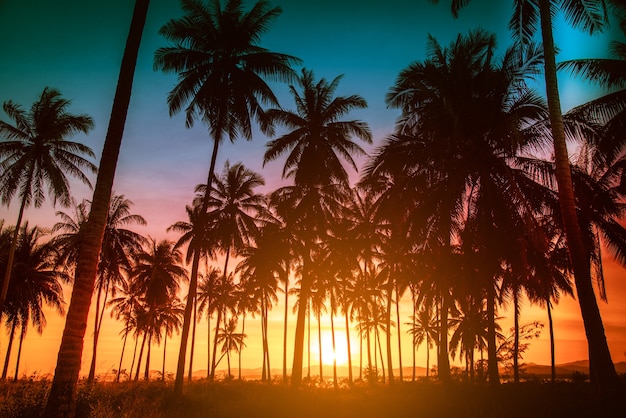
[0,223,67,380]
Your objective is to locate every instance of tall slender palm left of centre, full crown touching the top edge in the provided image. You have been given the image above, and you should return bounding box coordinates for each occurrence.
[154,0,299,394]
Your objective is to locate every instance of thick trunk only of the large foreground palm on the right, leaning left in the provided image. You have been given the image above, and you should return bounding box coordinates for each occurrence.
[539,0,618,392]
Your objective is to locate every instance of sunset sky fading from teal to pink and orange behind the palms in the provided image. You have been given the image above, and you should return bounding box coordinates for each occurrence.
[0,0,626,375]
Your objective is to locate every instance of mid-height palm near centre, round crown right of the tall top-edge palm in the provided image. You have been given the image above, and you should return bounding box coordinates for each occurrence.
[263,69,372,386]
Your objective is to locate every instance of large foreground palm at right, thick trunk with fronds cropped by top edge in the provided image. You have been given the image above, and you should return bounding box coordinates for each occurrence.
[432,0,624,390]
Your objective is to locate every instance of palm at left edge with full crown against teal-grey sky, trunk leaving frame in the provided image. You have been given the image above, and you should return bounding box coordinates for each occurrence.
[0,87,96,310]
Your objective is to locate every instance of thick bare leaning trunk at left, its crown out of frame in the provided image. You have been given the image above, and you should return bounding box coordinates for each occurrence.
[44,0,150,418]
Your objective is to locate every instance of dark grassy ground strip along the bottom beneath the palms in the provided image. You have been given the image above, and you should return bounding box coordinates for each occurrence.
[0,381,626,418]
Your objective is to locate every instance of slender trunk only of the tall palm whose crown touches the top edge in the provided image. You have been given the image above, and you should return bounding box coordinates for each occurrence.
[174,139,219,396]
